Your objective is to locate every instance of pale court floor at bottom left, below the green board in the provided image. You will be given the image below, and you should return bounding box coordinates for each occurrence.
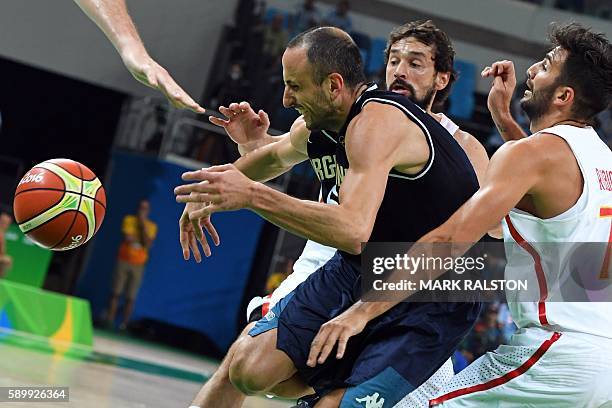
[0,332,293,408]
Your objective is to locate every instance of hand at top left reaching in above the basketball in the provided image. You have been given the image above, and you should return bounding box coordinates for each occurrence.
[121,52,205,113]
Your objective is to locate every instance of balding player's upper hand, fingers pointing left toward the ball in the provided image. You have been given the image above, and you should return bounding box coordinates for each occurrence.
[174,164,255,220]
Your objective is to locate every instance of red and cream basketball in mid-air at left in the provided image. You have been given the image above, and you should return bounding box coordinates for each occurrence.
[13,159,106,251]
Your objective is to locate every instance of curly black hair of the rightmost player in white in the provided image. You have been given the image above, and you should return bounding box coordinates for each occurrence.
[549,23,612,121]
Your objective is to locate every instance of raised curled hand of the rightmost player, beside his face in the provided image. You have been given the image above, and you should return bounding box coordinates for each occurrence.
[481,60,516,116]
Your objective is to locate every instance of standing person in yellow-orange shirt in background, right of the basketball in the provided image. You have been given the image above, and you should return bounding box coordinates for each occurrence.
[107,200,157,330]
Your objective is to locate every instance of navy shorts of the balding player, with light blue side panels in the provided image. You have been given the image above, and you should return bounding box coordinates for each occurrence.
[249,253,480,408]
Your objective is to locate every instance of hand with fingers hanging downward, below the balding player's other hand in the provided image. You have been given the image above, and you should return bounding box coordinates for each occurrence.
[179,203,220,263]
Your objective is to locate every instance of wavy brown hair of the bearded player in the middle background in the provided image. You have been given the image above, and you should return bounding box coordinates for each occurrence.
[385,20,458,106]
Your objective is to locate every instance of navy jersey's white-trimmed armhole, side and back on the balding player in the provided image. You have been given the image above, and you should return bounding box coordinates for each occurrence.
[336,87,478,264]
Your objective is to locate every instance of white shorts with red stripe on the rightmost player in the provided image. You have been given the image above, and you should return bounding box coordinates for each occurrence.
[430,327,612,408]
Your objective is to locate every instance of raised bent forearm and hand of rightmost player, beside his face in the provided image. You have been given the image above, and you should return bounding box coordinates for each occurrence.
[481,60,527,142]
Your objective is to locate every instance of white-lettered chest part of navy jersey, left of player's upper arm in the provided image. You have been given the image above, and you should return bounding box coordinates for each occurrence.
[306,130,338,204]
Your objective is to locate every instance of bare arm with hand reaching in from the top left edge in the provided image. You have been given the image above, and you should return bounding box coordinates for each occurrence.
[75,0,204,113]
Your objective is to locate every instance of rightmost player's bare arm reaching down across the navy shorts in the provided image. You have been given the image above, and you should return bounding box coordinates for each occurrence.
[308,140,547,367]
